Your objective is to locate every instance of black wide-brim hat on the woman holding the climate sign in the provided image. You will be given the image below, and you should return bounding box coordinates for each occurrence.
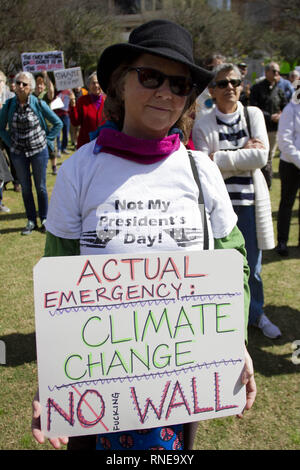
[97,20,214,94]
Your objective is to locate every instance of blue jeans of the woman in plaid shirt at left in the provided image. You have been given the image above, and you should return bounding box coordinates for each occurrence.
[11,146,49,223]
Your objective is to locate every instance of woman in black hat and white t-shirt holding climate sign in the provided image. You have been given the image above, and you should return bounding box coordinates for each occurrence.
[32,20,256,450]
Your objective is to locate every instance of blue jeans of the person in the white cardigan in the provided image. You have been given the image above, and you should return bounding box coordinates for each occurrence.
[233,206,264,325]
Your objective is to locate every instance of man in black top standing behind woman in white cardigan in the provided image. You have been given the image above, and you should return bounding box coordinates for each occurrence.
[250,62,287,188]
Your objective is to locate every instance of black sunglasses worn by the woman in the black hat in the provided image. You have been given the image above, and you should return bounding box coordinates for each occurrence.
[128,67,196,96]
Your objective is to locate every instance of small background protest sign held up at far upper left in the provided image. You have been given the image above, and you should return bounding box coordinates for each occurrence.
[21,51,65,73]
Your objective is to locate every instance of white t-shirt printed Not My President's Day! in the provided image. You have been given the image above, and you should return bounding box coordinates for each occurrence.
[46,141,237,255]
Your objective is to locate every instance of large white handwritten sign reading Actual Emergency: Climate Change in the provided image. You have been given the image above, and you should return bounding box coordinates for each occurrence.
[34,250,246,437]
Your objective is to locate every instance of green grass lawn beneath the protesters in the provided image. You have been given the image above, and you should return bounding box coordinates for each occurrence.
[0,152,300,450]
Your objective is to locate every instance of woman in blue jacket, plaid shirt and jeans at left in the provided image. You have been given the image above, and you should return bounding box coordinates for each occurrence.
[0,71,62,235]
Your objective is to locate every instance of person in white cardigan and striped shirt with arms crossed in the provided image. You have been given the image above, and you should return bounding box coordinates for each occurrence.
[193,64,281,339]
